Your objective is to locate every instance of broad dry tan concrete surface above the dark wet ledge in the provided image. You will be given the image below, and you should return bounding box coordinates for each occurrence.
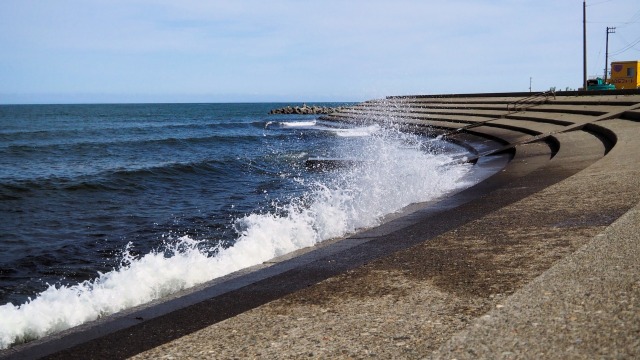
[135,94,640,359]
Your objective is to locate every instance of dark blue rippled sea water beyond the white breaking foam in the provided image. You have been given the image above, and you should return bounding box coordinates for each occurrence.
[0,104,356,304]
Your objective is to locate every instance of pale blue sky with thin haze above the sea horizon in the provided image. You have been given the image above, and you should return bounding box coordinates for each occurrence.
[0,0,640,104]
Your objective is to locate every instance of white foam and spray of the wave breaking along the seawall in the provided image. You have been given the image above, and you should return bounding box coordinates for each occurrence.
[0,128,476,348]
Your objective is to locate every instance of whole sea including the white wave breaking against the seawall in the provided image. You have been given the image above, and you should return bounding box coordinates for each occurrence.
[0,103,471,349]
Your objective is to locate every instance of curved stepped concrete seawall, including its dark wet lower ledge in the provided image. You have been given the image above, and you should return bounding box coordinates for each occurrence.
[5,91,640,359]
